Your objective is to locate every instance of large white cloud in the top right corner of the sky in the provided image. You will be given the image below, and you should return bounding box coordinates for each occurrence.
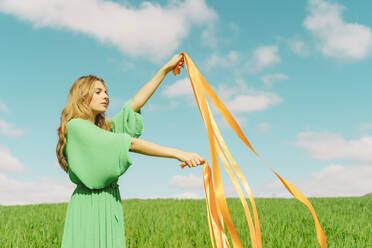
[304,0,372,60]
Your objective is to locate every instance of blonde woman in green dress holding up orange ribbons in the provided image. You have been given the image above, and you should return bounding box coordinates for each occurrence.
[56,55,205,248]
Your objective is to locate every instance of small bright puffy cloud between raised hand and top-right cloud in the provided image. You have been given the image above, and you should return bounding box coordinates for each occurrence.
[245,46,280,72]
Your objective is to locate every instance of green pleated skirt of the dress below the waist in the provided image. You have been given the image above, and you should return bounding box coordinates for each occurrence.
[61,182,125,248]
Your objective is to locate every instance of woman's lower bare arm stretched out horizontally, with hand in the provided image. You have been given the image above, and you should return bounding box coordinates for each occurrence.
[129,137,205,167]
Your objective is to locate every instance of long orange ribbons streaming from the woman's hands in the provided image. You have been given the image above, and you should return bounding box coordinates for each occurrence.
[173,52,326,248]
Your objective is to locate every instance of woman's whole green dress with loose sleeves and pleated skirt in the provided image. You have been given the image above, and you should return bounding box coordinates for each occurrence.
[61,99,144,248]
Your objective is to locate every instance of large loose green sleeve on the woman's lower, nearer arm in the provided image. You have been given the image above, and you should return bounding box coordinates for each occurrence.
[66,118,132,189]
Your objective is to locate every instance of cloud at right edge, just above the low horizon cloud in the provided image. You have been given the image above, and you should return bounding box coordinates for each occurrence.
[295,131,372,162]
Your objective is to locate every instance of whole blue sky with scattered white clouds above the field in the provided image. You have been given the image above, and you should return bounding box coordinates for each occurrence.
[0,0,372,205]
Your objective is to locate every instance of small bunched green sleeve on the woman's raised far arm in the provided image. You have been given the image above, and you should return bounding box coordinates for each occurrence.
[110,98,144,138]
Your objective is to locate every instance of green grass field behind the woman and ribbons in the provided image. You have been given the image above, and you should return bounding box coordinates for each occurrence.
[0,196,372,248]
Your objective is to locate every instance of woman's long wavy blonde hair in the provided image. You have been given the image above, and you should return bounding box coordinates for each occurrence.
[56,75,111,173]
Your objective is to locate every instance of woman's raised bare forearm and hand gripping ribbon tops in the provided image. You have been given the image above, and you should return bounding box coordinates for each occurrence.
[132,54,183,112]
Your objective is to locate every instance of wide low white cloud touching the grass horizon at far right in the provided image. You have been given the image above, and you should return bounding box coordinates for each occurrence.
[264,164,372,197]
